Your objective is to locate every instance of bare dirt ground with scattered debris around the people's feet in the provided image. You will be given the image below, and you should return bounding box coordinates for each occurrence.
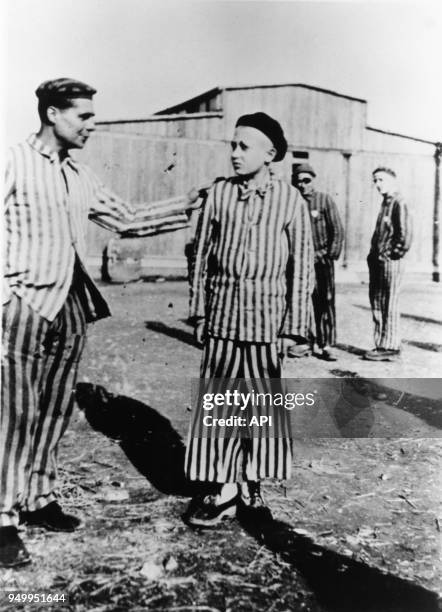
[0,281,442,612]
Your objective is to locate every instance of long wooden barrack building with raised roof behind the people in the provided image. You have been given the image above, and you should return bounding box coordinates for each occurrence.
[78,84,441,280]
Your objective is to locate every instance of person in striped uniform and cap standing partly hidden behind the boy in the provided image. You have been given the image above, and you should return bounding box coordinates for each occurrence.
[289,164,344,361]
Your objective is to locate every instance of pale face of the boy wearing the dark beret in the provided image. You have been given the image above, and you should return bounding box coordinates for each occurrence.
[230,125,276,177]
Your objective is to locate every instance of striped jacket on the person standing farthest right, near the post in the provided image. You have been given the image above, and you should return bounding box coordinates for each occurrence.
[370,192,412,260]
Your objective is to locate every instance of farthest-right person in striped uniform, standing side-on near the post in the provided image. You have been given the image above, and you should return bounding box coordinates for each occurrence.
[364,166,412,361]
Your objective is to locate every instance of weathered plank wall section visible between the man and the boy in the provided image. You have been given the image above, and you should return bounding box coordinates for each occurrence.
[77,132,229,267]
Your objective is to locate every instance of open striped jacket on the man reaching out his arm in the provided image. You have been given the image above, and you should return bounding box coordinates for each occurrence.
[3,134,188,321]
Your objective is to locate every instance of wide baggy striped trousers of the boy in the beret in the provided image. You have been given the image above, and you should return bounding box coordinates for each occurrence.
[185,337,292,483]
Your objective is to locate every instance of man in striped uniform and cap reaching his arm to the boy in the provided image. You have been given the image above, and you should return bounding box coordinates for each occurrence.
[0,79,188,567]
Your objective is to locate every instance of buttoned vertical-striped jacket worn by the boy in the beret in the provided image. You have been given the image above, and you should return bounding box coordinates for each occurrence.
[190,178,314,342]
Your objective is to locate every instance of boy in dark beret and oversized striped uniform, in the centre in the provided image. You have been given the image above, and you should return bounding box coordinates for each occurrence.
[186,113,314,526]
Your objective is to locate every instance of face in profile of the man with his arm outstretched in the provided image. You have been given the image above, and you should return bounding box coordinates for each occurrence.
[48,98,95,149]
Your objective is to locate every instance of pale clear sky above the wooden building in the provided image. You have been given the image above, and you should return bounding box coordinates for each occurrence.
[1,0,442,145]
